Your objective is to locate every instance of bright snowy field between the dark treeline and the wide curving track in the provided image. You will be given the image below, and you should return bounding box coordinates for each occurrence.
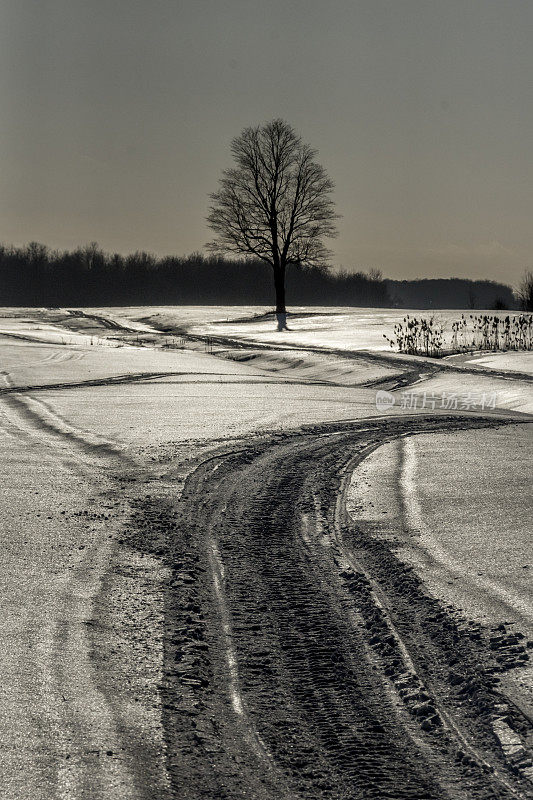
[0,307,533,592]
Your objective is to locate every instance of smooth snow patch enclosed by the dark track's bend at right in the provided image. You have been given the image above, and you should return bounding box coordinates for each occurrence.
[348,425,533,713]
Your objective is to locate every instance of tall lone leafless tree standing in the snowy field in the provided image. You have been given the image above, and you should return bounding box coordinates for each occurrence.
[207,119,337,330]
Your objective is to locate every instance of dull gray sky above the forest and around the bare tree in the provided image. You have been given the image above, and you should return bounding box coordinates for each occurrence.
[0,0,533,283]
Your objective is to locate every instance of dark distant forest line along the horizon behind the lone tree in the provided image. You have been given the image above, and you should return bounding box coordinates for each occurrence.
[0,242,515,309]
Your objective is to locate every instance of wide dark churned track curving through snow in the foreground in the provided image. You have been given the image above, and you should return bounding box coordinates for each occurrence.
[127,416,531,800]
